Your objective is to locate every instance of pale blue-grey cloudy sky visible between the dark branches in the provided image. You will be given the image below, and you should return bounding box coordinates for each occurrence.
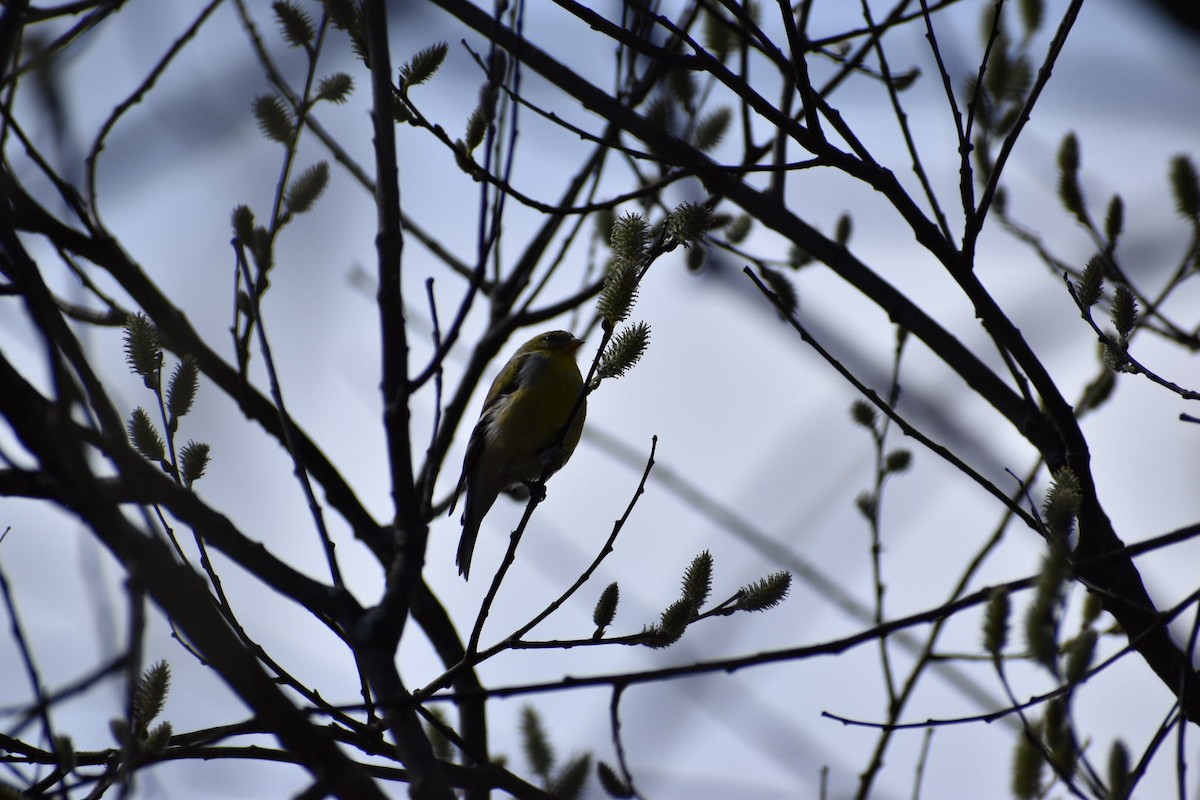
[0,0,1200,798]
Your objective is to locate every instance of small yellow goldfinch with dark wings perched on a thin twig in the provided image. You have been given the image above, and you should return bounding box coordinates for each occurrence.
[450,331,587,579]
